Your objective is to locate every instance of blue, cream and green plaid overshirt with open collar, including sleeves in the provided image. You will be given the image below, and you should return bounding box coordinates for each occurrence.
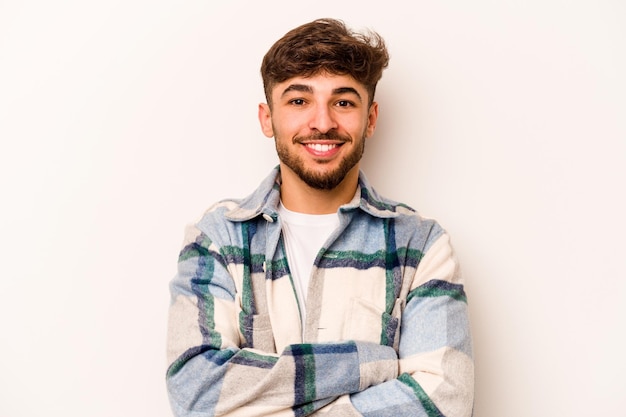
[167,169,473,417]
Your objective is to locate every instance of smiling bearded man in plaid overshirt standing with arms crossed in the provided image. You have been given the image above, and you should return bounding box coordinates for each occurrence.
[167,19,473,417]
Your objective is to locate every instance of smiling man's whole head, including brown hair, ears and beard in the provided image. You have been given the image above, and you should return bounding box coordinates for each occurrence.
[259,19,389,198]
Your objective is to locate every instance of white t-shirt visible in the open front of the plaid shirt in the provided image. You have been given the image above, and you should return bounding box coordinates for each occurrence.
[278,202,339,323]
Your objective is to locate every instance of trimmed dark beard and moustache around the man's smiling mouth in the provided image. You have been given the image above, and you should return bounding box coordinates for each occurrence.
[275,131,365,190]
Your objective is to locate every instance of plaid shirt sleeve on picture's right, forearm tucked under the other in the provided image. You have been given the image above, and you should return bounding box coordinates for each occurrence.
[344,233,474,417]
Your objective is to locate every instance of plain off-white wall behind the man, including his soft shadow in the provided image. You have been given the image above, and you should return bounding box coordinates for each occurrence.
[0,0,626,417]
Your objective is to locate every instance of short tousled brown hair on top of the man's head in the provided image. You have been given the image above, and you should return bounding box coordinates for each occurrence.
[261,19,389,106]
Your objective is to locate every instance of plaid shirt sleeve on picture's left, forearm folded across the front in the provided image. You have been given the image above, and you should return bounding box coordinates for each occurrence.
[166,227,398,417]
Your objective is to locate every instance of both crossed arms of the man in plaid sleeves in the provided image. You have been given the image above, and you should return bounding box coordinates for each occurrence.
[167,226,473,417]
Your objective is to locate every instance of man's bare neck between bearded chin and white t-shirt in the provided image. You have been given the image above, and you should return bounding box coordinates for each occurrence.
[280,167,359,214]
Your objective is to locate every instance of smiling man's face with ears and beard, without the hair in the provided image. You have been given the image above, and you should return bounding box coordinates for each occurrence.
[259,74,378,190]
